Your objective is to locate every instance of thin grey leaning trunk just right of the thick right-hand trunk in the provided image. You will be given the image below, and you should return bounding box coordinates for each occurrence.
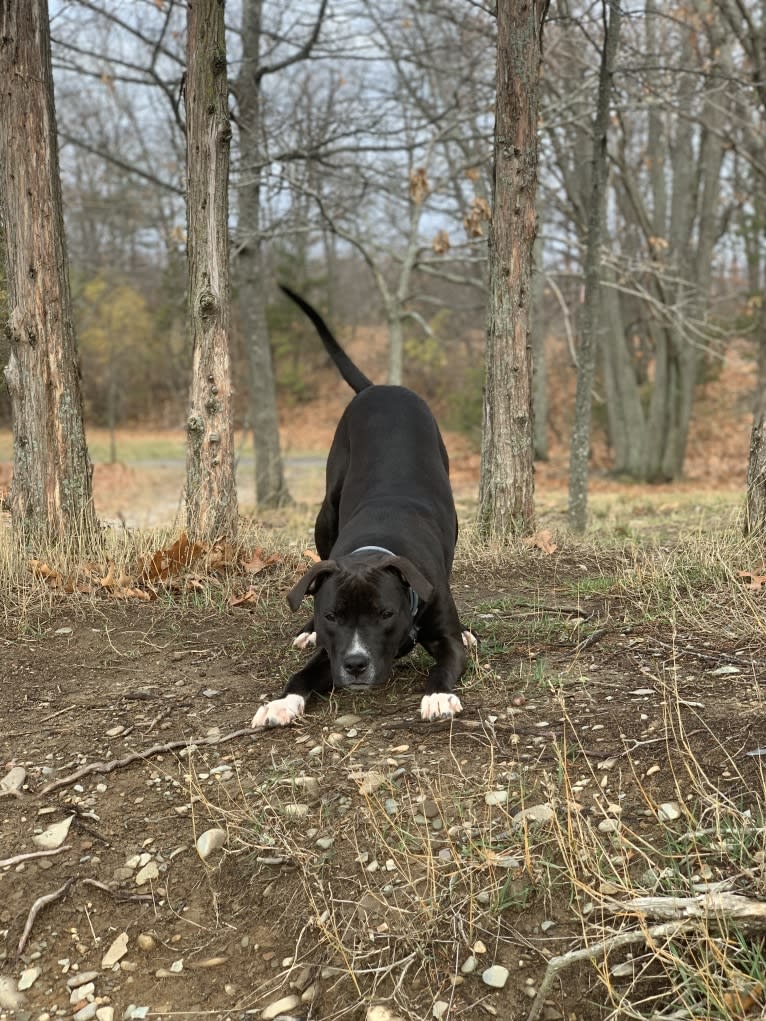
[569,0,621,532]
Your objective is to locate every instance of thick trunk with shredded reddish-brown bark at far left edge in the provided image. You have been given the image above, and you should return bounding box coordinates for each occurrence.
[0,0,98,542]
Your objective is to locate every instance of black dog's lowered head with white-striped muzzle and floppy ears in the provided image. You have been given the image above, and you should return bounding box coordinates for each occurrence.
[287,554,433,688]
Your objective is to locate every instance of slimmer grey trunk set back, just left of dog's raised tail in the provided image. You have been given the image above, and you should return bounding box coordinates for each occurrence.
[237,0,291,507]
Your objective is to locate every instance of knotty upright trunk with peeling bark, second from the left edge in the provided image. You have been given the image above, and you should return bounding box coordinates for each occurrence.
[186,0,237,541]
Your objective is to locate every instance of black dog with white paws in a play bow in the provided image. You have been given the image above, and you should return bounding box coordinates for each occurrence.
[252,287,475,727]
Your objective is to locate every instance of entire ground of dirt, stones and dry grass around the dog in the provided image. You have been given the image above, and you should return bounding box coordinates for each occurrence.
[0,345,766,1021]
